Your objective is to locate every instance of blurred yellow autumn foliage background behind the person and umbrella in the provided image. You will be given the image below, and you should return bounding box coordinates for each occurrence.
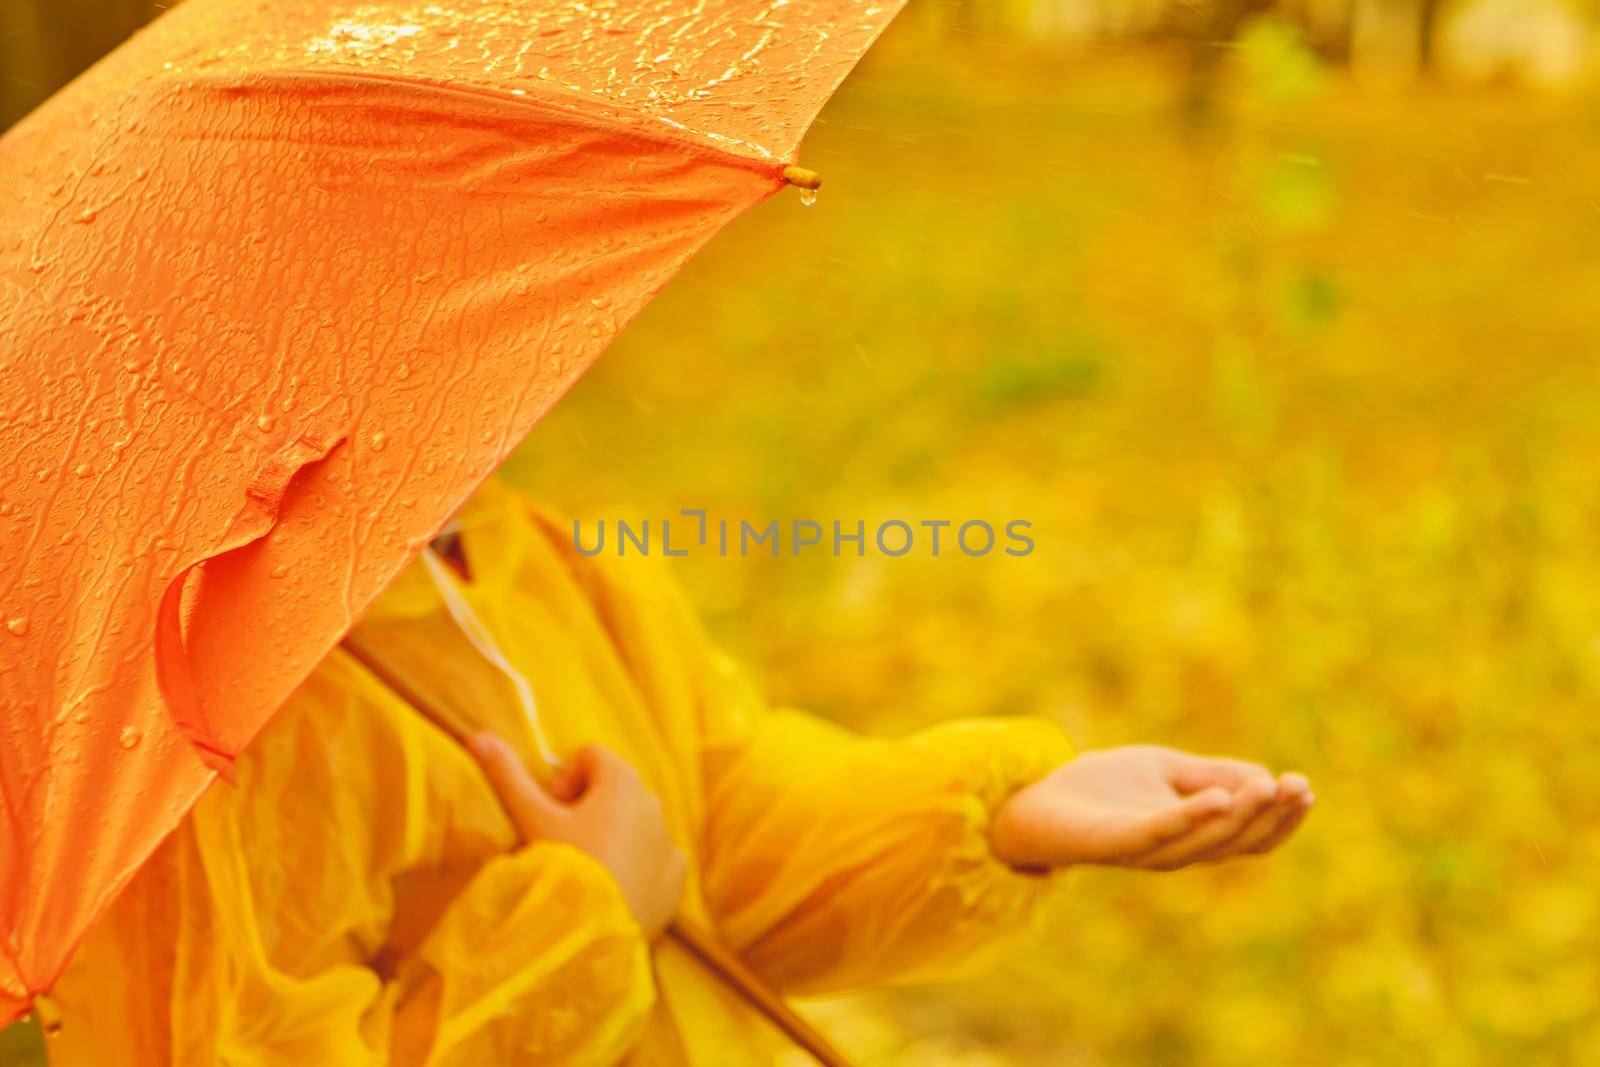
[0,0,1600,1067]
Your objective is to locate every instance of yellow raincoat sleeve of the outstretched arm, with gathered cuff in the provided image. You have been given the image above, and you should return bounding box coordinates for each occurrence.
[518,507,1070,993]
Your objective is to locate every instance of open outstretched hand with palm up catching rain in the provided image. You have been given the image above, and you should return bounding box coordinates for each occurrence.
[990,745,1315,870]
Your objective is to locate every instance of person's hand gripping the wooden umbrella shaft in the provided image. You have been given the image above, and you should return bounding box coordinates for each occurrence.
[469,734,688,937]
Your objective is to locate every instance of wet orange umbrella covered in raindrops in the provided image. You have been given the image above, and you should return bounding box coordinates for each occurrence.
[0,0,899,1019]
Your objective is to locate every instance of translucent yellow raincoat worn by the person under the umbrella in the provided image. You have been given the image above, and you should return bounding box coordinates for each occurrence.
[42,483,1069,1067]
